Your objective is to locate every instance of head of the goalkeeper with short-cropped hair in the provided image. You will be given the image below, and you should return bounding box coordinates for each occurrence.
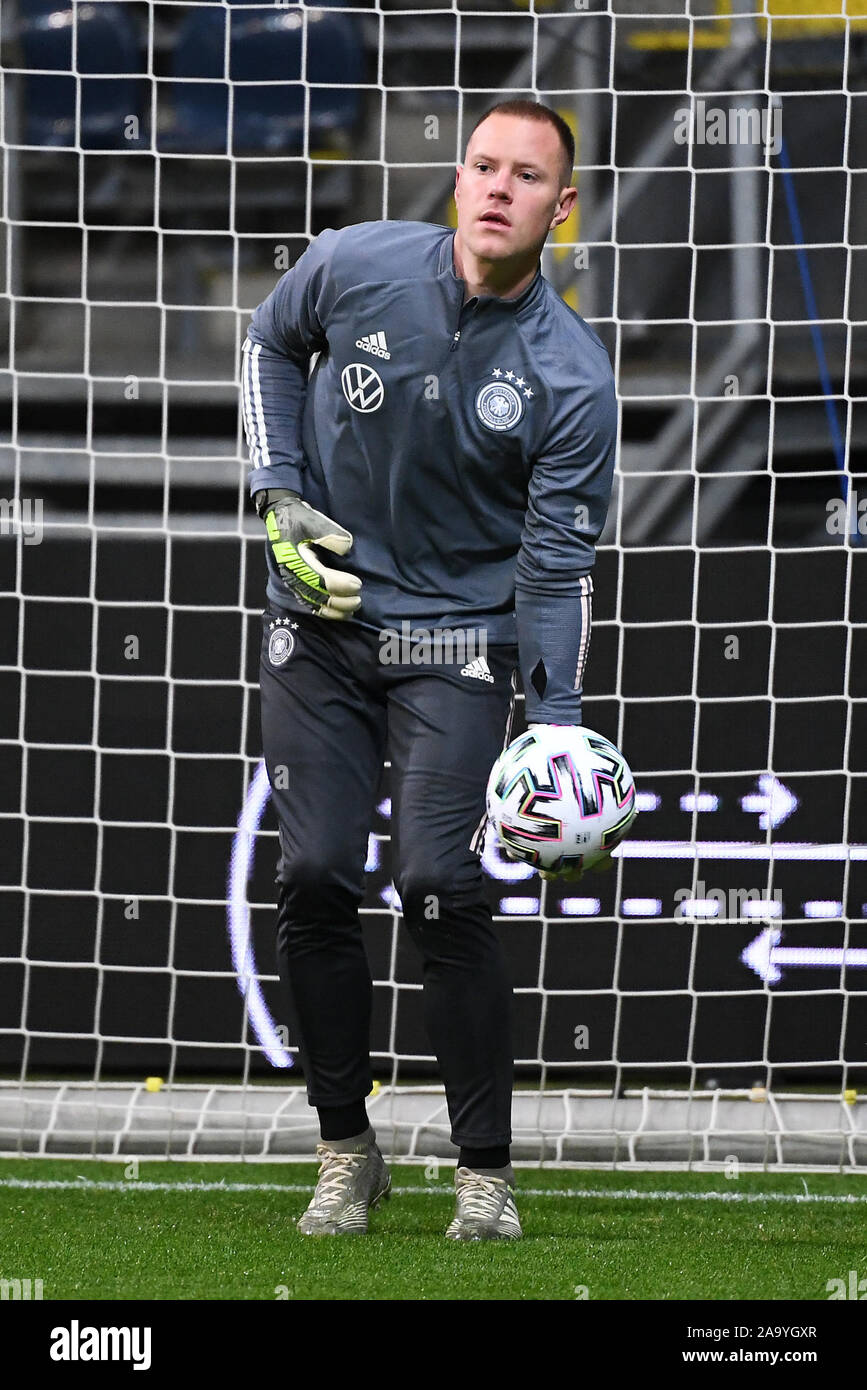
[454,113,578,271]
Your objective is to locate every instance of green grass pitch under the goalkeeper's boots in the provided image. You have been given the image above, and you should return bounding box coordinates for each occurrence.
[0,1159,867,1302]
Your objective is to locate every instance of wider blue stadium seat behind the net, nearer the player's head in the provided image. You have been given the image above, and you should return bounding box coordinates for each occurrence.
[163,4,364,154]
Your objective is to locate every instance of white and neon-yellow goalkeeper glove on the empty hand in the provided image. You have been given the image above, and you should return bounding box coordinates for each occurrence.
[256,488,361,619]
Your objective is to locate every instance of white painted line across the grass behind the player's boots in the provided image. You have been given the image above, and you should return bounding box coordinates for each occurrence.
[0,1177,867,1205]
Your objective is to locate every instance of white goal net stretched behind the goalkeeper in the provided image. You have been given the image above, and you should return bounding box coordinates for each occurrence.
[0,0,867,1168]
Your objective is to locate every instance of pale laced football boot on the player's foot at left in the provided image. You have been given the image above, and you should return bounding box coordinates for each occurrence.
[296,1130,392,1236]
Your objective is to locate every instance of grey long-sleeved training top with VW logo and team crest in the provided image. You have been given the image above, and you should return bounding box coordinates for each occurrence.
[243,221,617,723]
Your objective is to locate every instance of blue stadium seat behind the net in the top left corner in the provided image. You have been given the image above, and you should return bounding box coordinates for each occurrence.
[18,0,147,150]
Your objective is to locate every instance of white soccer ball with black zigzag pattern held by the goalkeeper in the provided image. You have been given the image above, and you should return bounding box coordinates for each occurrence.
[486,724,635,873]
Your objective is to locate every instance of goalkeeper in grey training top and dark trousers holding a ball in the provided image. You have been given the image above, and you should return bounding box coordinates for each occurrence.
[237,101,617,1240]
